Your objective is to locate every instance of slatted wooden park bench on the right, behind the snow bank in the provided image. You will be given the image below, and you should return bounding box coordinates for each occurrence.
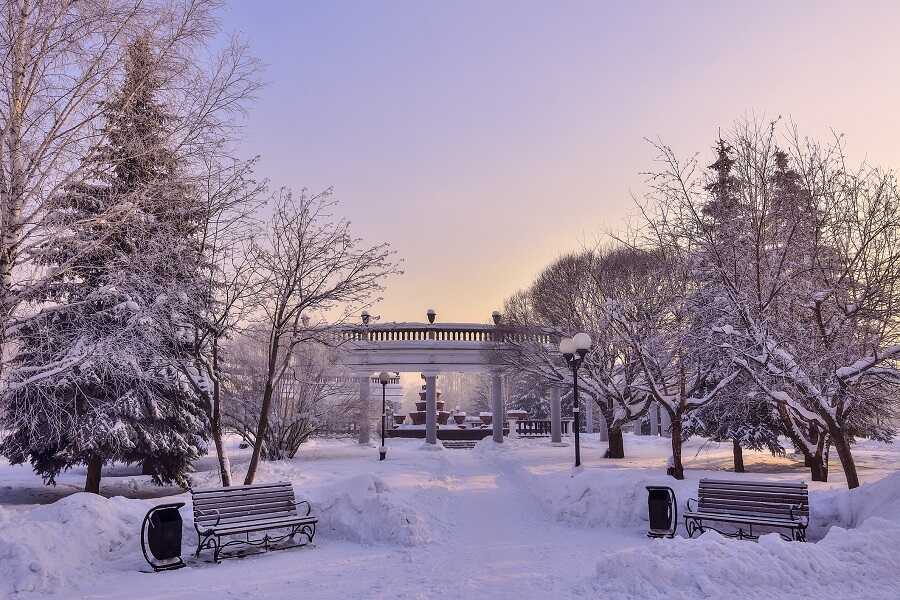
[684,479,809,542]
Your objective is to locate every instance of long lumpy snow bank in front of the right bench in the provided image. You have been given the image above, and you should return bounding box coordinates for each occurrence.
[591,518,900,600]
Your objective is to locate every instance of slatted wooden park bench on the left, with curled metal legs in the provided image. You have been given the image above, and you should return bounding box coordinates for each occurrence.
[191,482,318,562]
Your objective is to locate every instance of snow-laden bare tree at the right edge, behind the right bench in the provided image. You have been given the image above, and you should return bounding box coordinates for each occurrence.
[648,122,900,488]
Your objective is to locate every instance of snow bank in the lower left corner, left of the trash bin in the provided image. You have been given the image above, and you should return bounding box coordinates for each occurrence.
[0,493,150,597]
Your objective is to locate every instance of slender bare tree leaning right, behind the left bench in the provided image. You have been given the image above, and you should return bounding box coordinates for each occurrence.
[244,189,400,484]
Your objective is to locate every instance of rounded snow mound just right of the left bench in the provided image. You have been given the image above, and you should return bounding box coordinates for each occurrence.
[311,474,431,546]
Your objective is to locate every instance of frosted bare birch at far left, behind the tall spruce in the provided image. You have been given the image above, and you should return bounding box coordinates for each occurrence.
[0,0,258,385]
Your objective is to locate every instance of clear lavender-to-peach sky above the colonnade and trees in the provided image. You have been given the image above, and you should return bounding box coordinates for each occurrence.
[223,0,900,322]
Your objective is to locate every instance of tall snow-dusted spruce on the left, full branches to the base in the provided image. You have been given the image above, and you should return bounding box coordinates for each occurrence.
[0,39,208,492]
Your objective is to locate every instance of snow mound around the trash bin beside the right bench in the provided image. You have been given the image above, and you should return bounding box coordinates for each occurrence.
[543,469,697,529]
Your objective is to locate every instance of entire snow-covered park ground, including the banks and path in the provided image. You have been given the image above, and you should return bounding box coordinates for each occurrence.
[0,436,900,600]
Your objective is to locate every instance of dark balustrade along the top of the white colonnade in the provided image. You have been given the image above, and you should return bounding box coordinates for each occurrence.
[336,323,558,344]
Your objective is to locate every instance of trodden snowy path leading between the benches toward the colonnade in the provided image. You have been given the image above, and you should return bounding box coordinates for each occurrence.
[77,450,646,600]
